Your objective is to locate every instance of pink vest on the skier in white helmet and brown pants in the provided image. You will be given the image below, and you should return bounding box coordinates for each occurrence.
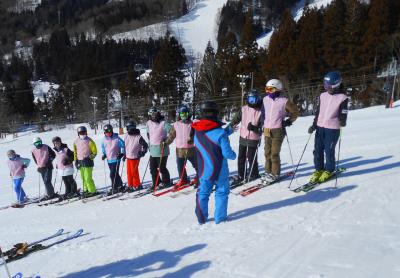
[263,96,288,129]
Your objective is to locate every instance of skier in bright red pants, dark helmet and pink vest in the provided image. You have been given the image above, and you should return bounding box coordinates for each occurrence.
[122,121,149,192]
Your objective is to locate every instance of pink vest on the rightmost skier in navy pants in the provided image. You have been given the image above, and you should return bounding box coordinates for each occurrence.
[317,92,347,129]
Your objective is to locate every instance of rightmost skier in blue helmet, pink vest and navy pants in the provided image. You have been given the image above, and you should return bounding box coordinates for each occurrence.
[308,71,349,183]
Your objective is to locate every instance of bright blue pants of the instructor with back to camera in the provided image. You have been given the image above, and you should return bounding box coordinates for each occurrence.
[195,177,229,224]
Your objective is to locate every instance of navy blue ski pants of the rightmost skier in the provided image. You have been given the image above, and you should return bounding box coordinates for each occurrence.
[314,127,340,172]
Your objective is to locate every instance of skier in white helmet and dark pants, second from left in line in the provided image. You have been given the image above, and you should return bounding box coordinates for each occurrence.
[32,137,58,200]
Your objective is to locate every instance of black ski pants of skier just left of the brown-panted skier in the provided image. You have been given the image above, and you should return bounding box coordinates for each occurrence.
[238,144,259,180]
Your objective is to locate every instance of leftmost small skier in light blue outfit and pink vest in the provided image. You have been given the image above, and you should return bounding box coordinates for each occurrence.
[7,150,31,204]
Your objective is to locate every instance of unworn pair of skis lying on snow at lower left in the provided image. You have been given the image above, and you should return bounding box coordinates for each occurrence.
[3,229,83,263]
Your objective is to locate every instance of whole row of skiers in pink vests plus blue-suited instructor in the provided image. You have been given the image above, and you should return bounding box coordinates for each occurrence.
[7,71,348,224]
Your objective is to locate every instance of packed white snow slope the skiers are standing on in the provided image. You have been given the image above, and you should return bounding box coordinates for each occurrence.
[0,103,400,278]
